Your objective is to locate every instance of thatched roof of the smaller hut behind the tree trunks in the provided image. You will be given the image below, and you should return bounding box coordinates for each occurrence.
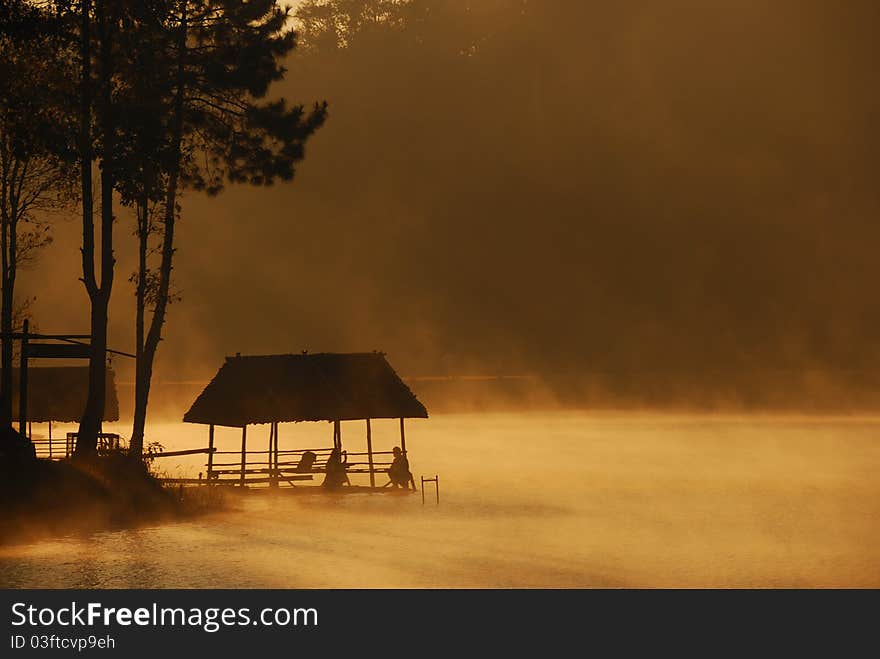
[12,366,119,423]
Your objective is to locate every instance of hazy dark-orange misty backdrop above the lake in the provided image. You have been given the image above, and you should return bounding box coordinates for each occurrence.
[22,0,880,404]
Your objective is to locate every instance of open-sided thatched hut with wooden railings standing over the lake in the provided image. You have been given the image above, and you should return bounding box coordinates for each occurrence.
[183,352,428,487]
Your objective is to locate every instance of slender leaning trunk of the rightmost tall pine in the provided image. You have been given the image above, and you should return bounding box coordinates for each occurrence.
[131,1,188,454]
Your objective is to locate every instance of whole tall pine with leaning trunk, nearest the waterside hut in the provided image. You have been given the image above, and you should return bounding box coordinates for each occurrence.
[118,0,326,454]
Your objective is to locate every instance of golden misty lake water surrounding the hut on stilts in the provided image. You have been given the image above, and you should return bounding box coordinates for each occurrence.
[0,413,880,588]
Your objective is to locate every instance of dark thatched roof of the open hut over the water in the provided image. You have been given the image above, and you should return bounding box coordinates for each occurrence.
[183,352,428,427]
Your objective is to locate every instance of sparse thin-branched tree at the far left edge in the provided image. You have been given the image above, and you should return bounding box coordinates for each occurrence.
[0,0,72,427]
